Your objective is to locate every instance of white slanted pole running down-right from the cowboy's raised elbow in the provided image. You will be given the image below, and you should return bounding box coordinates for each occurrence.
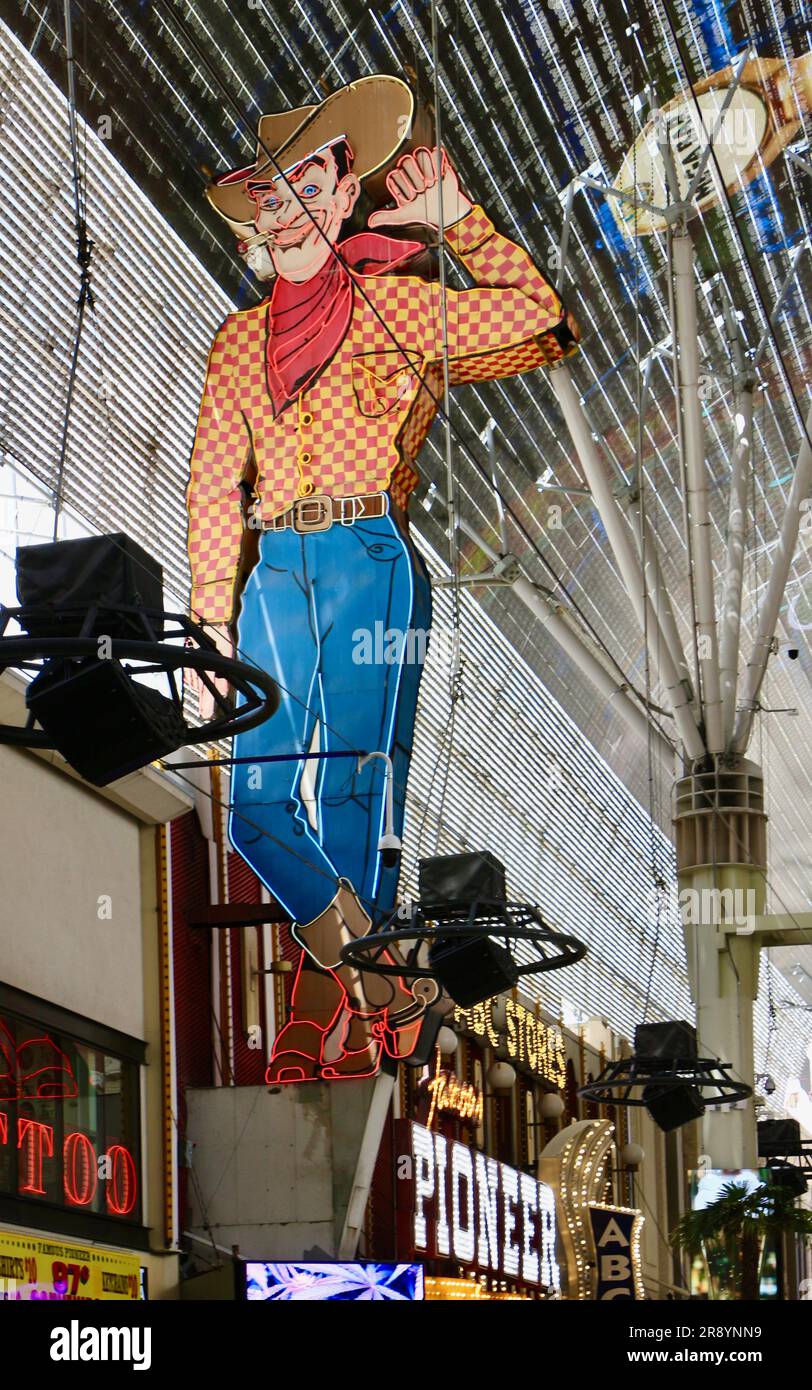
[549,364,705,762]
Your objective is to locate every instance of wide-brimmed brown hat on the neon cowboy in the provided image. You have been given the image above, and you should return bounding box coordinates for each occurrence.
[206,74,414,229]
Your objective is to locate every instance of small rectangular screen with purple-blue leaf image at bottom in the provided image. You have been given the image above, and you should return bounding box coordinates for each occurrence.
[245,1262,425,1302]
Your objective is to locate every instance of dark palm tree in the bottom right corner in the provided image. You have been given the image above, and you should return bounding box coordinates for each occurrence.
[672,1182,812,1300]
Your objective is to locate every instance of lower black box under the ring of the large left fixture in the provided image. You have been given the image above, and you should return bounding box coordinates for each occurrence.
[25,659,188,787]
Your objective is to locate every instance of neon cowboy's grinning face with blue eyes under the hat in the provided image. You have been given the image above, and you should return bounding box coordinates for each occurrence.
[246,150,360,281]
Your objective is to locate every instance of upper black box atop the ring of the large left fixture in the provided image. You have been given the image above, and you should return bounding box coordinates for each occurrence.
[17,532,164,639]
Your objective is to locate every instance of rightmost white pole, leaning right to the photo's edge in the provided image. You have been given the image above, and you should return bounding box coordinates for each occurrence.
[733,406,812,753]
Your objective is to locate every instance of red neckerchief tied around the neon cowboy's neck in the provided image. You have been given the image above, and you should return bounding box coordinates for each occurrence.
[267,232,423,416]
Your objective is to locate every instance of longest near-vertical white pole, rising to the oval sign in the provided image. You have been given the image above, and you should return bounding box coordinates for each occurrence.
[672,231,724,753]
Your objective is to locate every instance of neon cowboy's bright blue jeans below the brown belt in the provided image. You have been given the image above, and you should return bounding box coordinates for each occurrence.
[229,516,431,923]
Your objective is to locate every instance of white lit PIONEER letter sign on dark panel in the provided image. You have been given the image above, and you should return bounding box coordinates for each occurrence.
[398,1122,560,1290]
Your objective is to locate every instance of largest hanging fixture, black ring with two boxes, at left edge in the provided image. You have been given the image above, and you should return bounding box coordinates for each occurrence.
[0,534,279,787]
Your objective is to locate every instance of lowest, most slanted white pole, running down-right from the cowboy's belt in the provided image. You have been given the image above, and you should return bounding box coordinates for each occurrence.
[435,492,674,766]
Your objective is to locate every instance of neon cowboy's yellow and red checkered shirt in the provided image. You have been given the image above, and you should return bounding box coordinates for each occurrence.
[186,207,574,623]
